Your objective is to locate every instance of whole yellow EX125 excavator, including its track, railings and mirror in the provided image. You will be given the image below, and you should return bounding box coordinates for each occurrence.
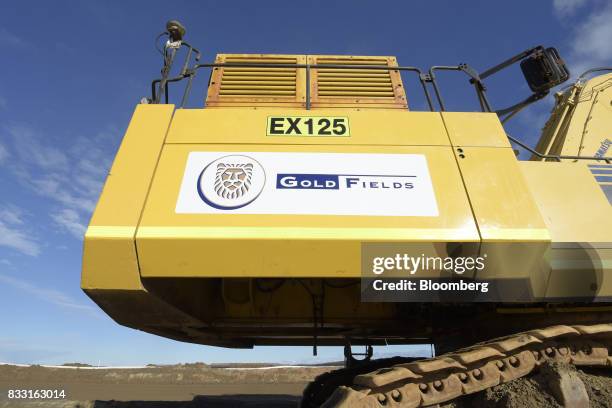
[82,21,612,407]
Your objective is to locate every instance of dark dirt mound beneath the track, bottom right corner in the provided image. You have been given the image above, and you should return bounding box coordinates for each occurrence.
[441,363,612,408]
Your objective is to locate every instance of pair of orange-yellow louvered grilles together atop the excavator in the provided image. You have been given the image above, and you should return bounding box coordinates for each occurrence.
[206,54,407,109]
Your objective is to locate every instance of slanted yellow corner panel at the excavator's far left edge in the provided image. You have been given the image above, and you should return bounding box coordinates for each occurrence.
[81,105,174,289]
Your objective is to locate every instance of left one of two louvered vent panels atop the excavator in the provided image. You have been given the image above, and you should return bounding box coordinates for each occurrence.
[206,54,306,107]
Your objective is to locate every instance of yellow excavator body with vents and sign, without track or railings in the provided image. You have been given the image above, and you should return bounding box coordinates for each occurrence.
[82,55,612,347]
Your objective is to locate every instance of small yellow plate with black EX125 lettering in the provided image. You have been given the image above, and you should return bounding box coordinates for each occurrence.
[266,116,351,137]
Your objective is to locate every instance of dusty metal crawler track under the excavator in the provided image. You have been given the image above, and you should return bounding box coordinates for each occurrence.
[315,323,612,408]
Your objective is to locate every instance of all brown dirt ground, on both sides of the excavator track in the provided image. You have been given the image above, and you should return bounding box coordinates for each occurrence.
[0,364,612,408]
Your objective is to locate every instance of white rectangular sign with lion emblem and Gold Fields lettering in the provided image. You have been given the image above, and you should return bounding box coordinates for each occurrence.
[176,152,438,217]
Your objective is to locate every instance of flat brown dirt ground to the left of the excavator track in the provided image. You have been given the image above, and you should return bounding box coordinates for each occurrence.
[0,364,332,408]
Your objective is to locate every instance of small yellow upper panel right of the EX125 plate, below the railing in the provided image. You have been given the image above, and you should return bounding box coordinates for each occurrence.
[441,112,510,147]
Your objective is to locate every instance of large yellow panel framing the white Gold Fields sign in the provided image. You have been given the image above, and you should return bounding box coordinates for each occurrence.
[136,144,479,277]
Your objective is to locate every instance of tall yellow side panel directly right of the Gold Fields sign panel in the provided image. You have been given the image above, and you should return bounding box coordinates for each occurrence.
[450,147,550,299]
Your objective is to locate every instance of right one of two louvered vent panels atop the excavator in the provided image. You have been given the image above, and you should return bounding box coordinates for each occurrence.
[308,55,407,109]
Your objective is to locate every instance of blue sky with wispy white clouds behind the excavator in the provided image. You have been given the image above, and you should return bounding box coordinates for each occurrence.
[0,0,612,365]
